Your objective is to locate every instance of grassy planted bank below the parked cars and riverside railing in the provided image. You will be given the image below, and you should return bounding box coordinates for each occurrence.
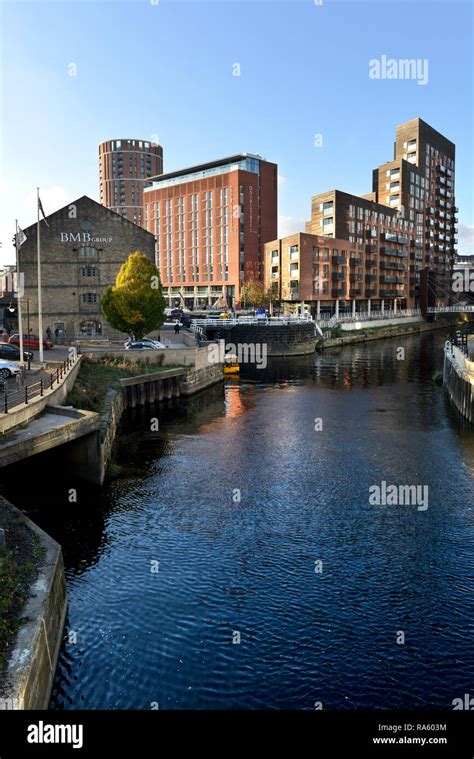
[66,354,177,413]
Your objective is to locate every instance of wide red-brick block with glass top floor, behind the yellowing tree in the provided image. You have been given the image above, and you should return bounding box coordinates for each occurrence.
[144,153,277,307]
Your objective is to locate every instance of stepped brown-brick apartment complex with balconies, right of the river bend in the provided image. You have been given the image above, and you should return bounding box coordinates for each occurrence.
[265,119,457,314]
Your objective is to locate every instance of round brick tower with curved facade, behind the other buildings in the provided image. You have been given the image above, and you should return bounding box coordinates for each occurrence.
[99,139,163,226]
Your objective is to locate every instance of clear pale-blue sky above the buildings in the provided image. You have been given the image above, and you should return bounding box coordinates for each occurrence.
[0,0,474,263]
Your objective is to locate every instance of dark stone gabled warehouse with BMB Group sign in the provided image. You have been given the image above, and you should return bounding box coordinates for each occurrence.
[19,195,155,340]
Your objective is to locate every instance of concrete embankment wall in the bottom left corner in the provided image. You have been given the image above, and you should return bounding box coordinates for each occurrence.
[0,497,67,709]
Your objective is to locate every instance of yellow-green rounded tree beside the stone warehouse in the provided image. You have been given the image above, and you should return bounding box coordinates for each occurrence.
[100,251,165,340]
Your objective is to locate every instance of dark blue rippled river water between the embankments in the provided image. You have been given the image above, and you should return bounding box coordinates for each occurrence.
[0,333,474,709]
